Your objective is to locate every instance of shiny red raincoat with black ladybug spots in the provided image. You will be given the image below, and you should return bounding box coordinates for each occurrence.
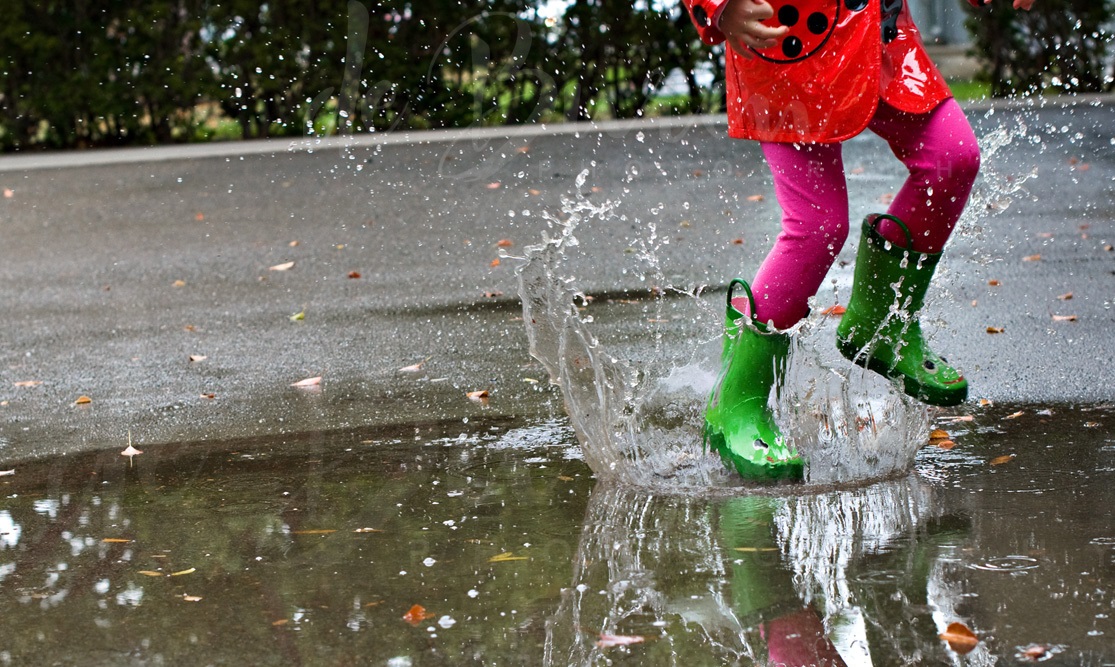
[683,0,952,143]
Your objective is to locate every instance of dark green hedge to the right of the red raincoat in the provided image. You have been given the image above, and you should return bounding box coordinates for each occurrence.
[962,0,1115,97]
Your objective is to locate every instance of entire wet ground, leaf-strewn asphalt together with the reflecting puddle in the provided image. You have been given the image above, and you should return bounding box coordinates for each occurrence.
[0,99,1115,667]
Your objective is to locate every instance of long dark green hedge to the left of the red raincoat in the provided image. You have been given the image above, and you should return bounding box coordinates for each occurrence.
[0,0,723,149]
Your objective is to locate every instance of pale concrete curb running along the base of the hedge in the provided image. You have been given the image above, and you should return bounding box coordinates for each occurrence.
[0,94,1115,173]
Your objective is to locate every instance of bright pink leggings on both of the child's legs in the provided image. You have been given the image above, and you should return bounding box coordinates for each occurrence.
[752,99,979,329]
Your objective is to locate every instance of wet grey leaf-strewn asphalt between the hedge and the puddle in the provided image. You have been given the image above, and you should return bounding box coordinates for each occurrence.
[0,98,1115,470]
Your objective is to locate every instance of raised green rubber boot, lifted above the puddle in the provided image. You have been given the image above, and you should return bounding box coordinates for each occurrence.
[836,214,968,406]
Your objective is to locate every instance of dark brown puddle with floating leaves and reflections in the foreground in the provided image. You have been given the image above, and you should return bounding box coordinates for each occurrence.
[0,406,1115,666]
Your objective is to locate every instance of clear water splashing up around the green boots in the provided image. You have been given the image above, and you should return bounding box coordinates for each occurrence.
[517,171,929,490]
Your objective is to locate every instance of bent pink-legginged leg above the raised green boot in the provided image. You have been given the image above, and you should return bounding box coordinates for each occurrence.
[869,99,979,253]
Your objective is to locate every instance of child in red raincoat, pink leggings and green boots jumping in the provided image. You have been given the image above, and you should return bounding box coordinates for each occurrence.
[685,0,1035,480]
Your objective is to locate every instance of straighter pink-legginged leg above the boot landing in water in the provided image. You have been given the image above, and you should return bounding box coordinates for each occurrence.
[752,143,849,329]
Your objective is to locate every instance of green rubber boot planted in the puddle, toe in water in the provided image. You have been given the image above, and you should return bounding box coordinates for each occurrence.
[705,279,805,482]
